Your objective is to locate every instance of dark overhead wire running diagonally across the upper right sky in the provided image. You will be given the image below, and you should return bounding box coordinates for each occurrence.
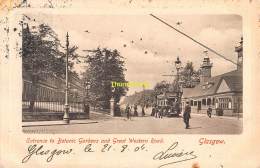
[150,14,239,66]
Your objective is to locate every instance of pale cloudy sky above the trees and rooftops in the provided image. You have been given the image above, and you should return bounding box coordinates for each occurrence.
[28,13,242,95]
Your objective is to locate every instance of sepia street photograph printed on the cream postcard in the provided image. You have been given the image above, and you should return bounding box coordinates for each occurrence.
[19,12,243,134]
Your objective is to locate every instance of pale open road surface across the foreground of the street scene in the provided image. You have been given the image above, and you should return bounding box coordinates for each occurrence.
[23,113,243,134]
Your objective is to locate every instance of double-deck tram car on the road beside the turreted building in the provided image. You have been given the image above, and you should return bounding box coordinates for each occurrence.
[156,92,181,117]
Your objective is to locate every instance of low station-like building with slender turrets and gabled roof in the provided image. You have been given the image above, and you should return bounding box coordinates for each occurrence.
[182,39,243,116]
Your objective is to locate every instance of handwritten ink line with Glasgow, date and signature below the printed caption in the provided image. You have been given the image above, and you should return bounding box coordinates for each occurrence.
[22,142,197,168]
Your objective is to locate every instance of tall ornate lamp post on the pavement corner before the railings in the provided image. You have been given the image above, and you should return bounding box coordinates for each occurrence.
[63,32,70,124]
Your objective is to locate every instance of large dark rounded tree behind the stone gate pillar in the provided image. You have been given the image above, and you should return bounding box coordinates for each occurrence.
[85,48,128,109]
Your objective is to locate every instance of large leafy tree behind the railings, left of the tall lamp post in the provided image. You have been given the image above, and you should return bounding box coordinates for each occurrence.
[22,24,78,111]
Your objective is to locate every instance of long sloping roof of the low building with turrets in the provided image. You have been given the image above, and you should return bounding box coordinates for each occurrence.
[182,70,243,98]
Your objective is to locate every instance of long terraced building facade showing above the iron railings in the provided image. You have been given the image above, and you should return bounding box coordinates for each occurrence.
[22,71,84,102]
